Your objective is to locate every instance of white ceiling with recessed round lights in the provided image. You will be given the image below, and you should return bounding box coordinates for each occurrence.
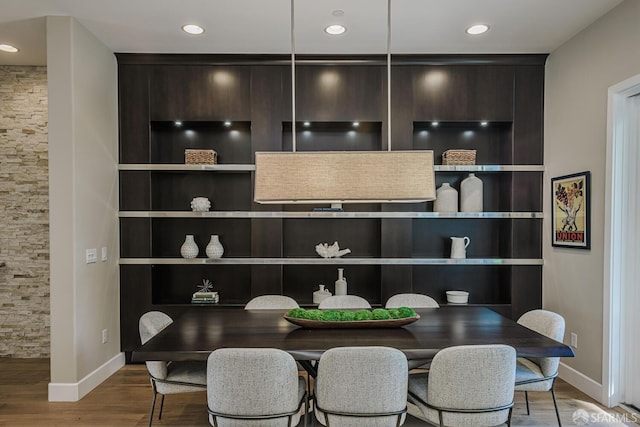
[0,0,622,65]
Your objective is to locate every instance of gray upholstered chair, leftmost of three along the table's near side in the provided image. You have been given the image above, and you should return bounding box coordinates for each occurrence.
[207,348,308,427]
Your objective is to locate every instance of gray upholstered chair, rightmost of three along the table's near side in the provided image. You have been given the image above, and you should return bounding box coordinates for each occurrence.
[409,344,516,427]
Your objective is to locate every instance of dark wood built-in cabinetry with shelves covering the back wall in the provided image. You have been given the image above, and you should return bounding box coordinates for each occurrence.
[118,54,545,352]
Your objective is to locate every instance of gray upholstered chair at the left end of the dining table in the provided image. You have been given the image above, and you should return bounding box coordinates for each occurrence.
[138,311,207,426]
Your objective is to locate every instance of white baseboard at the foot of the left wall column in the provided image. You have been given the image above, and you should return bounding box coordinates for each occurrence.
[49,353,125,402]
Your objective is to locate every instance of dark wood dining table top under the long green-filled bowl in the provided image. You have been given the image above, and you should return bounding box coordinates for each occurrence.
[132,306,574,362]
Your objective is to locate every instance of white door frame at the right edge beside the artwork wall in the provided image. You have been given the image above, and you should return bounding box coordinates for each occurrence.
[601,74,640,407]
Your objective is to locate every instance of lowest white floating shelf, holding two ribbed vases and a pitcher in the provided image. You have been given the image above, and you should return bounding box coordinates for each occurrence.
[120,257,543,265]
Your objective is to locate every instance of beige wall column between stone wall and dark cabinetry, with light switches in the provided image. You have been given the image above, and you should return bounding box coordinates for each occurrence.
[47,17,124,400]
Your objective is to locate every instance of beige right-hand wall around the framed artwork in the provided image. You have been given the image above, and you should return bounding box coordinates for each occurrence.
[543,0,640,398]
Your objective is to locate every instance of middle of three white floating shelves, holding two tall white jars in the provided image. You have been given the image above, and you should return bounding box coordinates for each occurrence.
[119,211,544,219]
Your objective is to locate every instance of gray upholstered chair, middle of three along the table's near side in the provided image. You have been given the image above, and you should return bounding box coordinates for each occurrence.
[314,347,407,427]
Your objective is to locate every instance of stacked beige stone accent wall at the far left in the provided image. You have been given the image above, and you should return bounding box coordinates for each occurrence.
[0,66,50,358]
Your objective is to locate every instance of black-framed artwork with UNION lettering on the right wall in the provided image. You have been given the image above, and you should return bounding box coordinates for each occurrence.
[551,172,591,249]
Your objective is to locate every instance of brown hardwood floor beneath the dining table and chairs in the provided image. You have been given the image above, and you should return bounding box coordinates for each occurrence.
[0,358,638,427]
